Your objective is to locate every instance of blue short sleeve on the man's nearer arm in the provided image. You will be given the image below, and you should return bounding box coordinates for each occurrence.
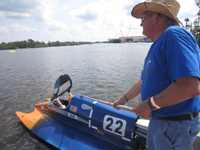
[165,30,200,82]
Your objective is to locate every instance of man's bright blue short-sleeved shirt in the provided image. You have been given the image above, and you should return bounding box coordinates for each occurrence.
[141,26,200,117]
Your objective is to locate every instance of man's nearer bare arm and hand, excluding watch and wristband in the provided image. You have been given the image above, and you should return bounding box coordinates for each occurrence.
[136,76,200,118]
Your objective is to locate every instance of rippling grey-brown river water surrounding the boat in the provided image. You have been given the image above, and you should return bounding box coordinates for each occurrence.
[0,43,151,150]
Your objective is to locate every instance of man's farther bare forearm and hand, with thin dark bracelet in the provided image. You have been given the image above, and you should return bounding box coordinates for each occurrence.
[113,79,142,109]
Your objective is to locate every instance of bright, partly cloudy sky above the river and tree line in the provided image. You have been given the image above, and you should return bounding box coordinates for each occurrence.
[0,0,199,43]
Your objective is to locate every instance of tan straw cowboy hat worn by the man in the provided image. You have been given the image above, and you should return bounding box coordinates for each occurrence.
[131,0,180,23]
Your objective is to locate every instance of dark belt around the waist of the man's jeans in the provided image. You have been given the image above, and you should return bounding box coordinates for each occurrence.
[158,112,199,121]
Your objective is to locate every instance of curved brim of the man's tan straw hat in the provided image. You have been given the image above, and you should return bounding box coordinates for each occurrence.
[131,2,178,23]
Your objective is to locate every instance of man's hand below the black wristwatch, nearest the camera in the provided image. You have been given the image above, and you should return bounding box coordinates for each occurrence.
[135,100,152,119]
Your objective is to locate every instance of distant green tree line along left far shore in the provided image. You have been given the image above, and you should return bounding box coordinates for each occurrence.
[0,39,91,50]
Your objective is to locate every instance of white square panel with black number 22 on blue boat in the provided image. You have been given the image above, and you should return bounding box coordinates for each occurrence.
[103,115,126,136]
